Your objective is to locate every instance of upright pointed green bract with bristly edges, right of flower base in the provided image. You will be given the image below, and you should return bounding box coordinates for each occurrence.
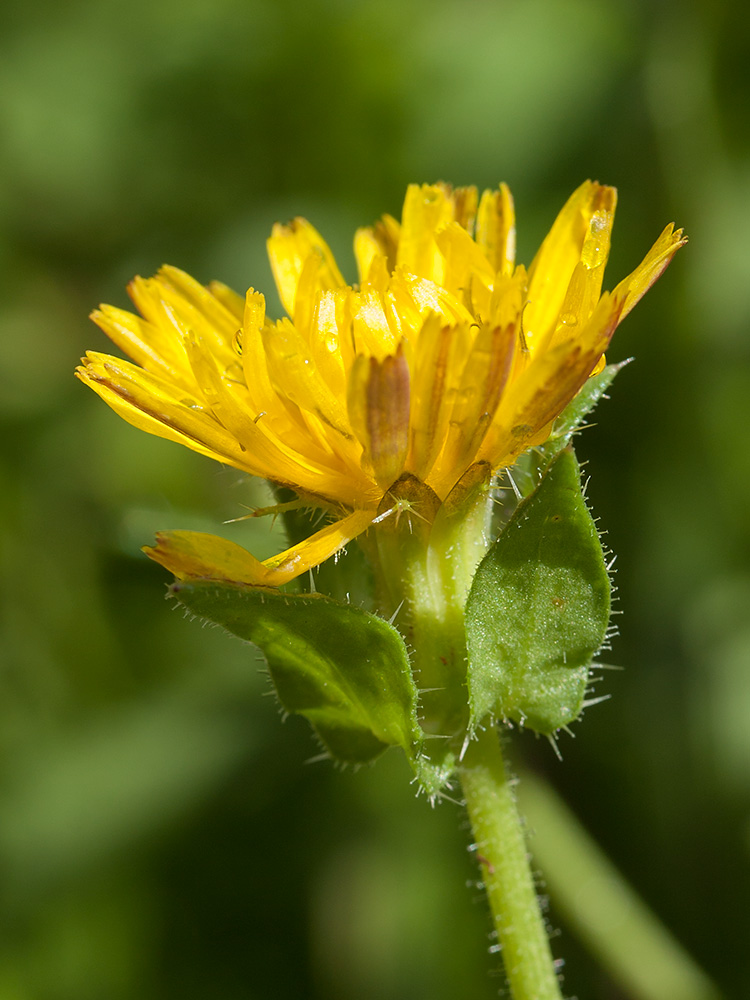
[466,448,610,734]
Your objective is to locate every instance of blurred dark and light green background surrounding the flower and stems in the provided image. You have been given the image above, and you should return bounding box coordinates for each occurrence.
[0,0,750,1000]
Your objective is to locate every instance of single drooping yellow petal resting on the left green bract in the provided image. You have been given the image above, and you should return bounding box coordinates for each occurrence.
[143,510,375,587]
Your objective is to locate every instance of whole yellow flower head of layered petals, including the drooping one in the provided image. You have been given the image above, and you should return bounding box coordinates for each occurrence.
[78,181,685,585]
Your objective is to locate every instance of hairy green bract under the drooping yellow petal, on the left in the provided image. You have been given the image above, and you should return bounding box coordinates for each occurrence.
[170,581,422,764]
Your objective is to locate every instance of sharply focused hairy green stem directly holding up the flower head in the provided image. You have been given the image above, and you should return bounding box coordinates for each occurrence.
[460,726,562,1000]
